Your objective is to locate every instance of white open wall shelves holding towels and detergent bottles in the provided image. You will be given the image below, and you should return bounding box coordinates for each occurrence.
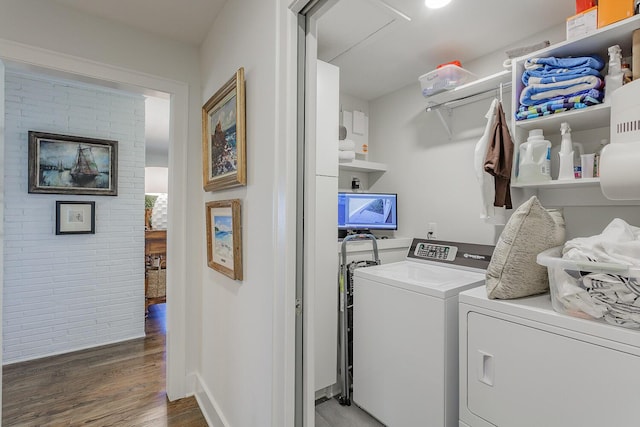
[511,16,640,192]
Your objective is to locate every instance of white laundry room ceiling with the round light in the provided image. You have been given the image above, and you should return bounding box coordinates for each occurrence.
[318,0,575,100]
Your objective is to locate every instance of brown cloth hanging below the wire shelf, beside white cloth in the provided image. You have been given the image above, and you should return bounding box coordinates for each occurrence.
[484,104,513,209]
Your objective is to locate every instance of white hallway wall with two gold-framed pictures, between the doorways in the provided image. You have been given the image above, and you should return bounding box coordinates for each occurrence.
[198,0,295,427]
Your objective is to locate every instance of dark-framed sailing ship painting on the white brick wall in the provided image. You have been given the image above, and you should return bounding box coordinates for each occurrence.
[28,131,118,196]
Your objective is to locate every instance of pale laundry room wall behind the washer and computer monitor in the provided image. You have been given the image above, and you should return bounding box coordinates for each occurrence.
[362,22,564,244]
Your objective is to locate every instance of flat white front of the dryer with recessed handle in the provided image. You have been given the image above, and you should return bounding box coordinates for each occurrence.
[466,312,640,427]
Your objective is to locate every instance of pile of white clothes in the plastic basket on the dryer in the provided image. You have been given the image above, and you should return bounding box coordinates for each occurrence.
[556,218,640,328]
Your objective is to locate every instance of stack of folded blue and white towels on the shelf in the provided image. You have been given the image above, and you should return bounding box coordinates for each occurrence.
[516,55,604,120]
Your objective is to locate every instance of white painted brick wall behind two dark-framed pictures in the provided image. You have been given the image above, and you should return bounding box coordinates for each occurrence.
[3,70,145,364]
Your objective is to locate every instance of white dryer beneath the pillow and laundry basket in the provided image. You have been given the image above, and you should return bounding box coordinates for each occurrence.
[459,287,640,427]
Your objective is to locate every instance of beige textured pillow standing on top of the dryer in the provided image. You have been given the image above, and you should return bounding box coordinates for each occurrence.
[486,196,565,299]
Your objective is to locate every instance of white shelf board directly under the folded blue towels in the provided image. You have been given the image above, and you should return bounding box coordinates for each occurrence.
[515,104,611,134]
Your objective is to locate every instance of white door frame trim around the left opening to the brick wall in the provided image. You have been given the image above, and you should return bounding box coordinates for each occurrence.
[0,39,193,400]
